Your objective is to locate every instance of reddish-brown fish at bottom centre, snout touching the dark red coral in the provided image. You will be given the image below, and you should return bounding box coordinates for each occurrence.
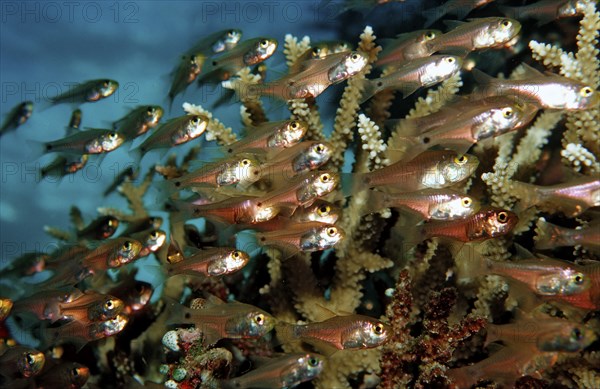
[275,315,391,351]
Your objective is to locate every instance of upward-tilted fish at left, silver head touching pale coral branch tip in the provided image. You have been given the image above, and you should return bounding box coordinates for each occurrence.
[136,115,208,154]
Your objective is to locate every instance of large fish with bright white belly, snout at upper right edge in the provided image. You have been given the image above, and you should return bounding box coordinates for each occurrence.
[472,64,600,111]
